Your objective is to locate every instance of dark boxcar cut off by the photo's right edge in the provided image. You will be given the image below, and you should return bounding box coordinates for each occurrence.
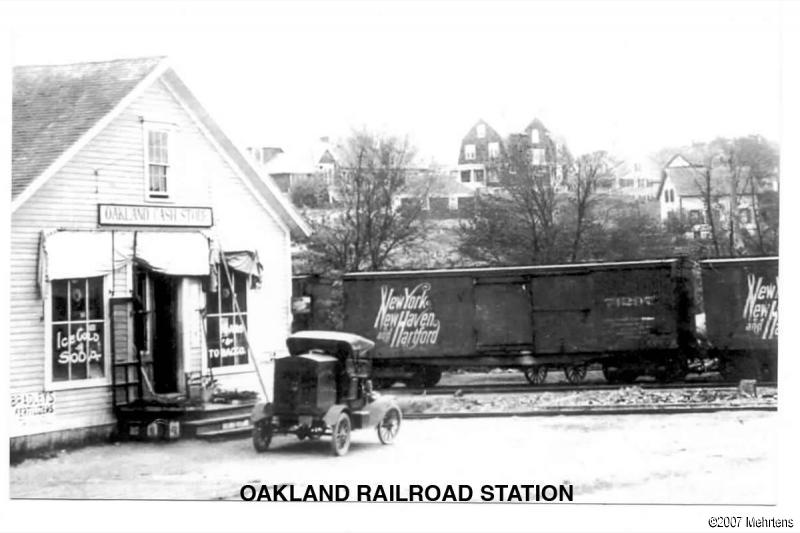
[700,257,778,381]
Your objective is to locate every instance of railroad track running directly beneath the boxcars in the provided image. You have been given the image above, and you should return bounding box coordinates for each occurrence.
[381,381,777,396]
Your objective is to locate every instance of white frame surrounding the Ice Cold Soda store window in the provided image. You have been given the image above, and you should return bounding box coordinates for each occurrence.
[44,275,113,391]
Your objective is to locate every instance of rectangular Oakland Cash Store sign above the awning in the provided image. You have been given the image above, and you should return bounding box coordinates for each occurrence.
[97,204,214,228]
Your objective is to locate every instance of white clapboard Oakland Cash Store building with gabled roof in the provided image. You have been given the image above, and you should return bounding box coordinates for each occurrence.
[8,58,309,453]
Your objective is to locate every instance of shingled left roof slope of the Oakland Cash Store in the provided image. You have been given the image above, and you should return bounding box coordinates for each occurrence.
[11,57,163,198]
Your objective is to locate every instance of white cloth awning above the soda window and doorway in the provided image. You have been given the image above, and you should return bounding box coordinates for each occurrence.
[39,231,212,285]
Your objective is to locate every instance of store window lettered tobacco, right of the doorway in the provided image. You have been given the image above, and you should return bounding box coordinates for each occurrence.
[206,266,248,368]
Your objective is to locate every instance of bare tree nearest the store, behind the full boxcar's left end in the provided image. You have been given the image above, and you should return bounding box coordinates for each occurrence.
[309,131,425,271]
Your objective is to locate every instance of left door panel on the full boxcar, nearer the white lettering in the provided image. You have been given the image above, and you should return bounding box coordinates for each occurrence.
[474,278,533,351]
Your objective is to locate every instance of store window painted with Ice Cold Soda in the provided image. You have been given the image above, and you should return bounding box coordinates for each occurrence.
[50,277,105,382]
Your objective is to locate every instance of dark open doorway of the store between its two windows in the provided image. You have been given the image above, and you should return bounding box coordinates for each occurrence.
[134,266,181,394]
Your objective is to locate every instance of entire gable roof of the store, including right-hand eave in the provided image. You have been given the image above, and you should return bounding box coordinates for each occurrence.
[12,57,311,236]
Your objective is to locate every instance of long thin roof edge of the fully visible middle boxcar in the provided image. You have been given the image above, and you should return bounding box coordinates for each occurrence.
[344,258,679,279]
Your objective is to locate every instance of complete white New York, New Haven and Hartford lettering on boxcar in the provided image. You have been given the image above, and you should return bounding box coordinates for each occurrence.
[373,283,441,349]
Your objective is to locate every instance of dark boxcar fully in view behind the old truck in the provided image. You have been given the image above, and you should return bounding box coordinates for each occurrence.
[344,259,694,386]
